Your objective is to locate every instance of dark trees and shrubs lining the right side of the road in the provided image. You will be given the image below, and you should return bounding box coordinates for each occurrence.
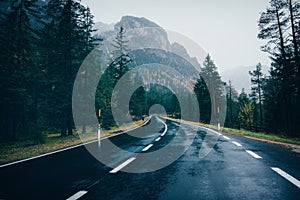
[216,0,300,137]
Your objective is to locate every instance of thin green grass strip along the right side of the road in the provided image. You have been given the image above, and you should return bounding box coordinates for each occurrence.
[166,117,300,145]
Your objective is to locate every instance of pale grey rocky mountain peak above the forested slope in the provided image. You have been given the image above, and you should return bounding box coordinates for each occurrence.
[96,16,200,72]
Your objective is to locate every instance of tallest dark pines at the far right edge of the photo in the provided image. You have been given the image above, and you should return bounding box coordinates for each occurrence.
[252,0,300,136]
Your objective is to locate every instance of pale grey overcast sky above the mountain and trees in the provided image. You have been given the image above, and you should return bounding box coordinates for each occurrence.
[82,0,270,72]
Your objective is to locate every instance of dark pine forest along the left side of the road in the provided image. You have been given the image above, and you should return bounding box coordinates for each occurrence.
[0,0,145,143]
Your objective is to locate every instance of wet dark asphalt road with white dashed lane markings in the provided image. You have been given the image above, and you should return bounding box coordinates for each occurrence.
[0,117,300,199]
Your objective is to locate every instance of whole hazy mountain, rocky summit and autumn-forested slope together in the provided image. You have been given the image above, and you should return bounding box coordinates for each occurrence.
[97,16,200,92]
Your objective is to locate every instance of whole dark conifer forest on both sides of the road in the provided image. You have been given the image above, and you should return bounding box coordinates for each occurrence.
[0,0,300,145]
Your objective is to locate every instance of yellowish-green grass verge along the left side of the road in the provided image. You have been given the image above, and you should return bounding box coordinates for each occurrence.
[0,118,148,165]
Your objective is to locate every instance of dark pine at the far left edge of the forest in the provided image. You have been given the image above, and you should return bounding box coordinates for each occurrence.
[0,0,40,139]
